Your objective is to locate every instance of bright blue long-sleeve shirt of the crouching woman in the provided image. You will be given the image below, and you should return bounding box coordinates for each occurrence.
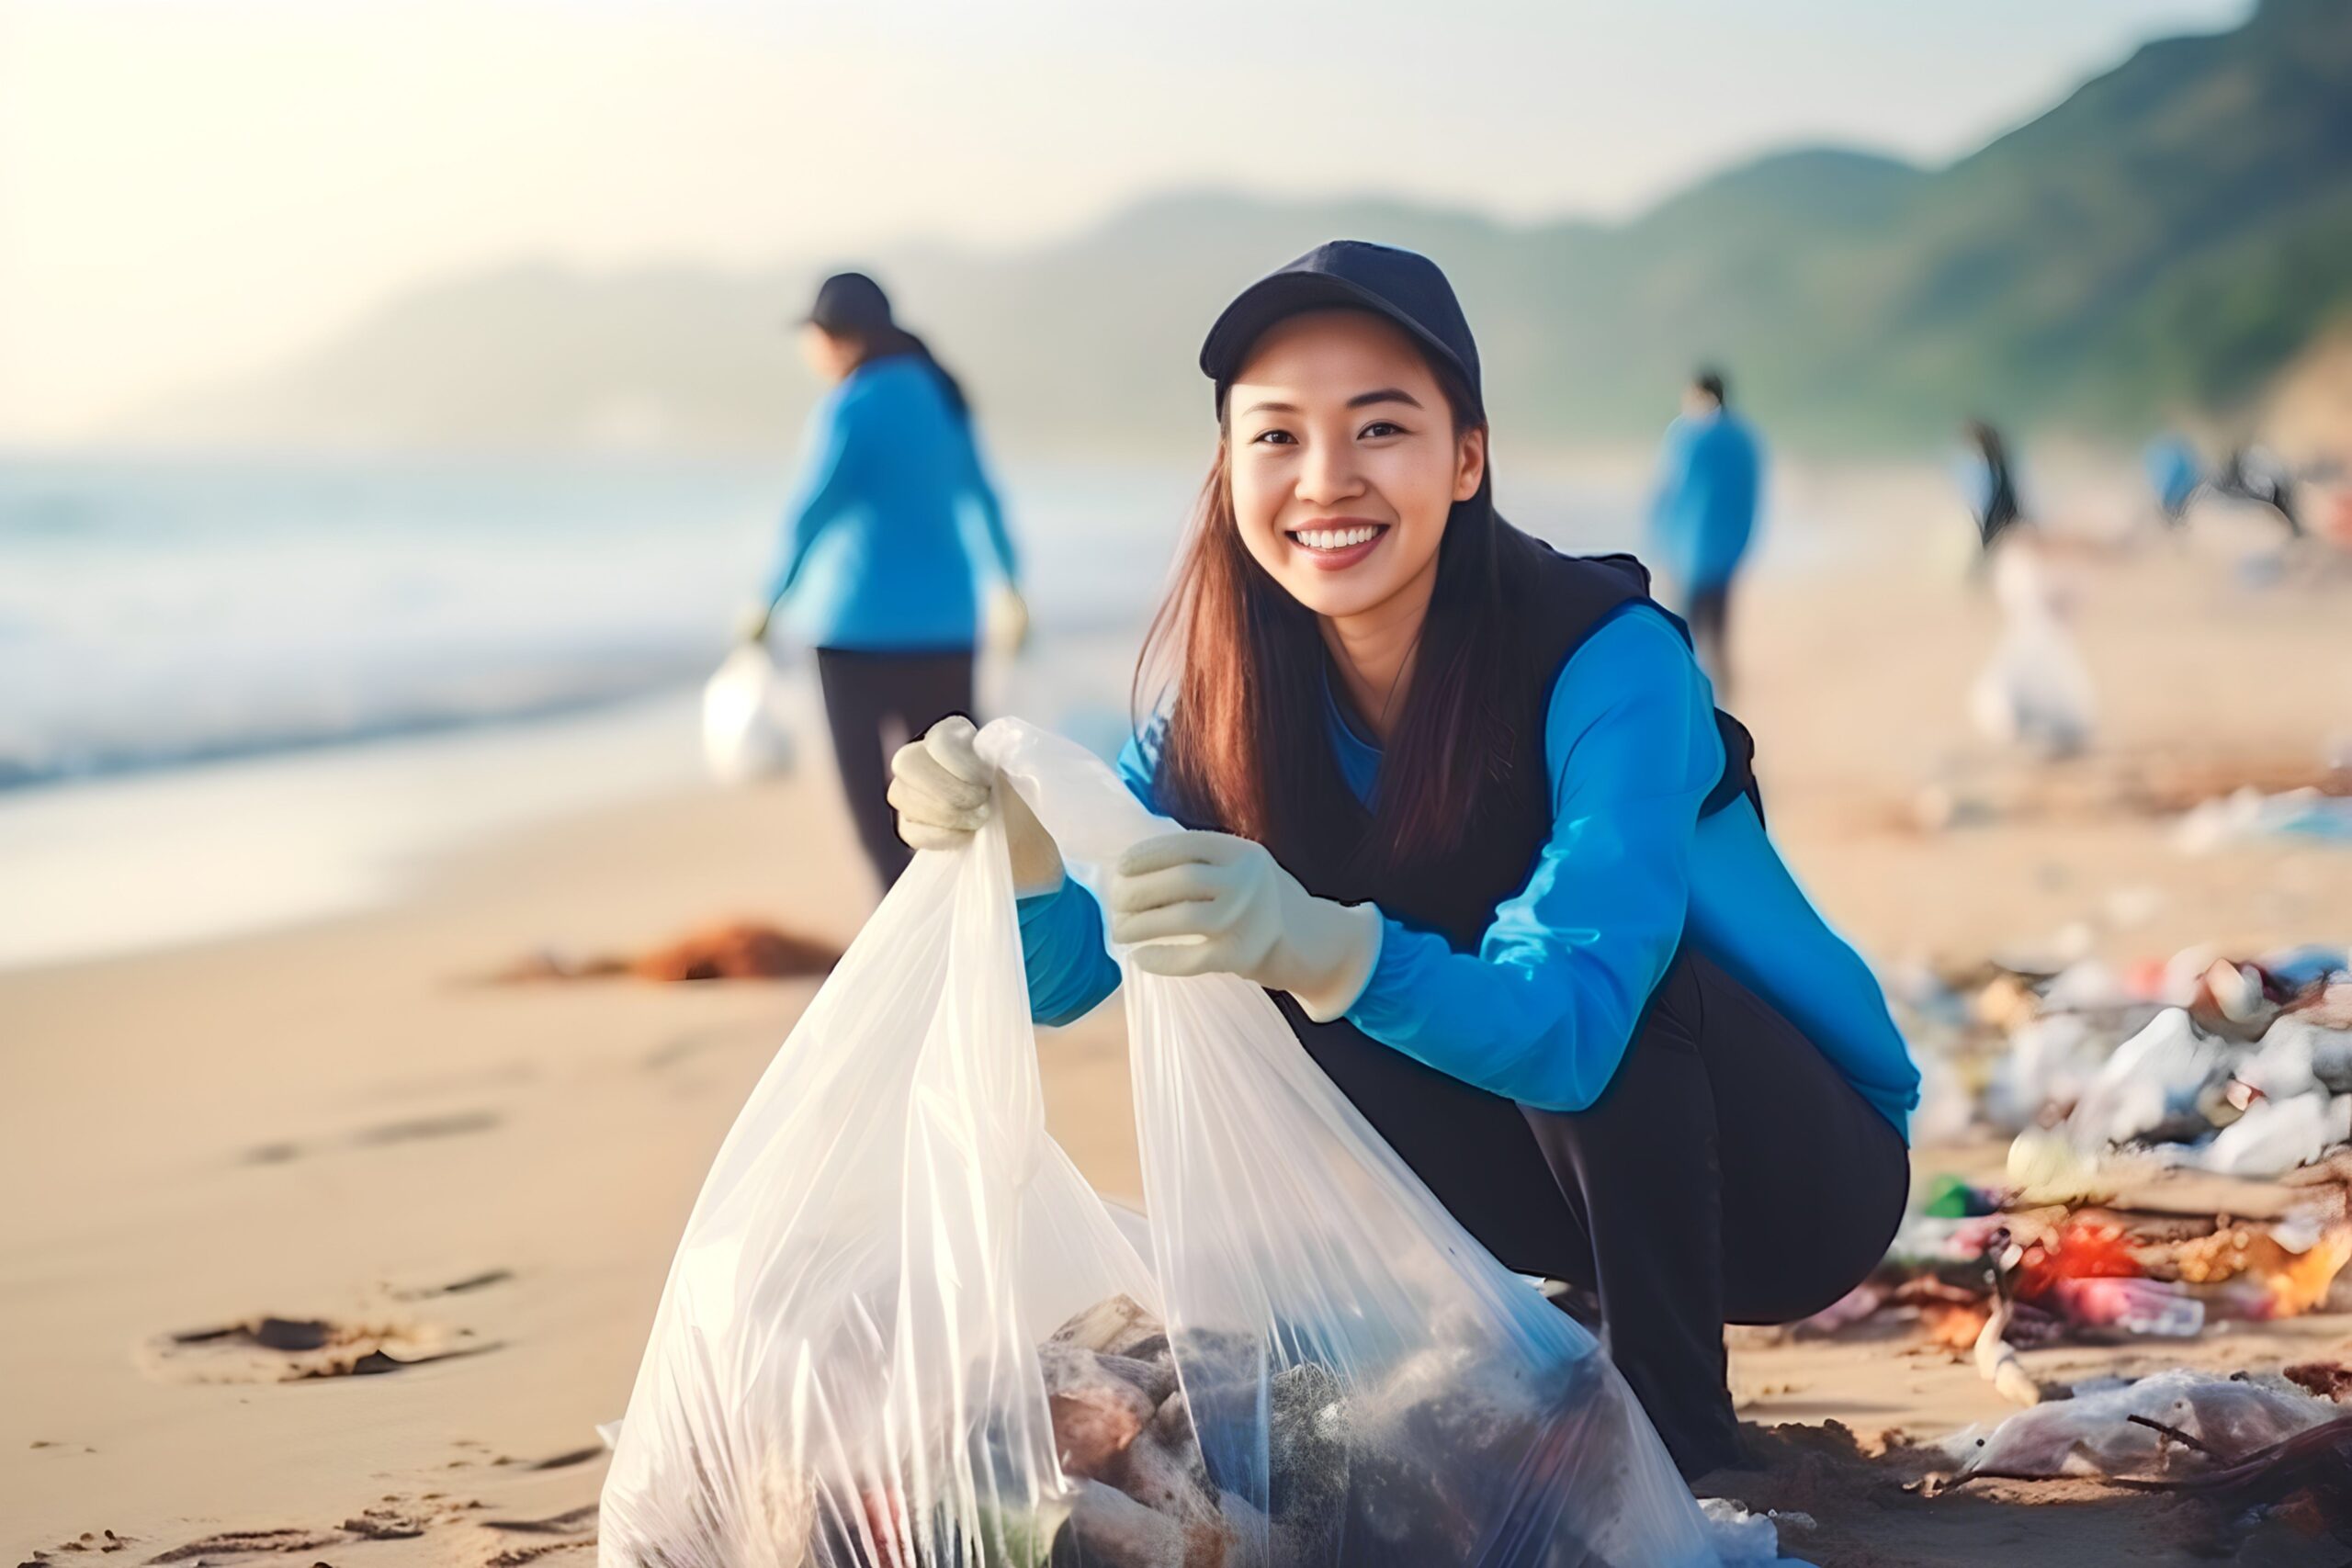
[1021,606,1919,1128]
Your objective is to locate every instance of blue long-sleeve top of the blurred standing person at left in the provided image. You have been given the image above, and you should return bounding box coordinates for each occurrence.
[767,355,1016,651]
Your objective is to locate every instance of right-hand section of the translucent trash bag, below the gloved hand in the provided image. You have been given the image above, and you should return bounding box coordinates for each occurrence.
[978,719,1713,1568]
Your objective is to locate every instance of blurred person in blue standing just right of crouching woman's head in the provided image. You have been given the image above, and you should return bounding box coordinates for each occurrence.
[1651,369,1764,696]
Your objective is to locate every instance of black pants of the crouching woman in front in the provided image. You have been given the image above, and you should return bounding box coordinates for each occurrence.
[1303,950,1910,1476]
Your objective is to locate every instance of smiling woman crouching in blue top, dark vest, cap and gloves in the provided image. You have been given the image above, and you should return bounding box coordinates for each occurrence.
[891,240,1919,1474]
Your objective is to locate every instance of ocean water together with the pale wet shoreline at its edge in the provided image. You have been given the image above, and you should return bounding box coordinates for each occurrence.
[0,456,1637,966]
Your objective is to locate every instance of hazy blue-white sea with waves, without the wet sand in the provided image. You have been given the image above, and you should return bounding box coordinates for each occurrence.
[0,456,1633,790]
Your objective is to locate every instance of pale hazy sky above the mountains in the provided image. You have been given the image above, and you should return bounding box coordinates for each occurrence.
[0,0,2248,440]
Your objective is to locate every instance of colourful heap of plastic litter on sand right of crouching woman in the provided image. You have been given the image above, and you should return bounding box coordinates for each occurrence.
[1792,947,2352,1540]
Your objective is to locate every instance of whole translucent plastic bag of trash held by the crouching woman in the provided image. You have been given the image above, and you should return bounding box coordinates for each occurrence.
[600,719,1717,1568]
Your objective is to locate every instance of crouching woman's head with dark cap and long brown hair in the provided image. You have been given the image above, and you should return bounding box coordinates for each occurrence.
[1138,243,1521,856]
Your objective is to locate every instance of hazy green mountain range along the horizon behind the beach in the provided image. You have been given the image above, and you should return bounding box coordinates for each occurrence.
[124,0,2352,451]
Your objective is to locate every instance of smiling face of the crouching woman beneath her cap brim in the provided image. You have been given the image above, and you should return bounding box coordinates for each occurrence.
[1226,310,1487,618]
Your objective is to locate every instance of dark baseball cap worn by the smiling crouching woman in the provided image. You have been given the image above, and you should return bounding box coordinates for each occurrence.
[1200,240,1487,416]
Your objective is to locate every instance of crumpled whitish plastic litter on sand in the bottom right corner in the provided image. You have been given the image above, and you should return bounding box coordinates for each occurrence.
[1945,1368,2343,1481]
